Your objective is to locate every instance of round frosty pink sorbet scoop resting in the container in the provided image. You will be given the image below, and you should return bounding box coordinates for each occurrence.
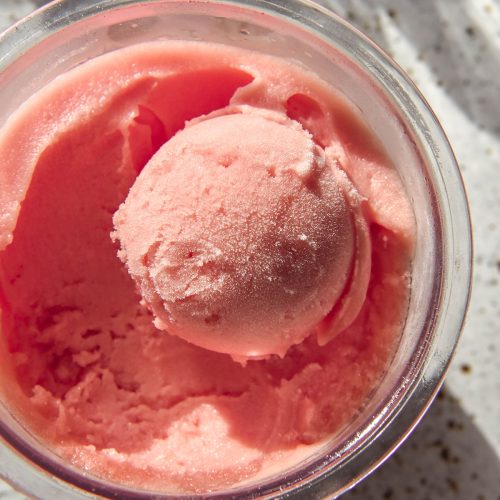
[114,107,366,358]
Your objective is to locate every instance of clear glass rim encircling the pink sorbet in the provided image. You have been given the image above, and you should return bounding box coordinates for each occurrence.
[0,0,472,499]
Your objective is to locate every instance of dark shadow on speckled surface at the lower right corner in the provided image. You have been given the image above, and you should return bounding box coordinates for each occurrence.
[342,387,500,500]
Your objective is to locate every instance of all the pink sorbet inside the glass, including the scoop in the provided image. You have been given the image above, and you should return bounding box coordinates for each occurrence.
[0,42,414,492]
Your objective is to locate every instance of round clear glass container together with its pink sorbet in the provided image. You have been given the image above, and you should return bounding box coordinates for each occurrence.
[0,0,471,498]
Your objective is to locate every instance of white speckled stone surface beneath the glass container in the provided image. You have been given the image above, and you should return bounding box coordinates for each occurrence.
[0,0,500,500]
